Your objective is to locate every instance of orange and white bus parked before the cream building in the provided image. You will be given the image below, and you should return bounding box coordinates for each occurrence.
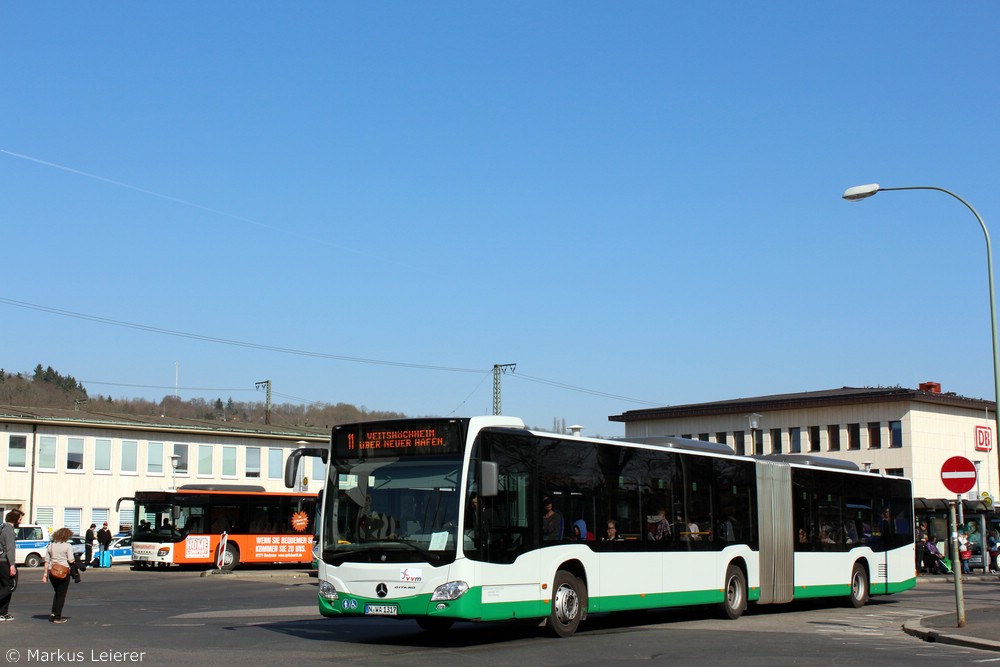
[118,484,317,570]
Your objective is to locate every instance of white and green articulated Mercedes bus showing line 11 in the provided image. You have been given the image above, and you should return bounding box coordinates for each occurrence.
[285,417,916,637]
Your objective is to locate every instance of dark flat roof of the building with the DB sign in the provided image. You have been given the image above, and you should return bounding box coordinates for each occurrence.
[608,383,996,422]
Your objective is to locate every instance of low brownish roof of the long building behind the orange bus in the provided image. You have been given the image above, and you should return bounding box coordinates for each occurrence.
[0,406,330,442]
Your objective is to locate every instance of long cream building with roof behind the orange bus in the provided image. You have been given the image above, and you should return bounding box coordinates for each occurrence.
[0,407,330,535]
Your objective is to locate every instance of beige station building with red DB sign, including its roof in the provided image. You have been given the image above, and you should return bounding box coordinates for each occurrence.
[610,382,1000,505]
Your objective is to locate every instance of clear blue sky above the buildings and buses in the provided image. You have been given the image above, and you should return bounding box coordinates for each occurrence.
[0,1,1000,435]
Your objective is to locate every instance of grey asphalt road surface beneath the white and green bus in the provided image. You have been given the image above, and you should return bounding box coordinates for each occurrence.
[0,566,1000,667]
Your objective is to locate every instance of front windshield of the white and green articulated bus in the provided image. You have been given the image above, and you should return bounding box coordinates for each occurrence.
[323,455,462,565]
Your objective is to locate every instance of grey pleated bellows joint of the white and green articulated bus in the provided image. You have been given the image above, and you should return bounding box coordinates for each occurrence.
[757,461,795,604]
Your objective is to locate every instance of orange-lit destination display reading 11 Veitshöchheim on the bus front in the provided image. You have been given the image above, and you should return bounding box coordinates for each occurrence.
[333,420,462,459]
